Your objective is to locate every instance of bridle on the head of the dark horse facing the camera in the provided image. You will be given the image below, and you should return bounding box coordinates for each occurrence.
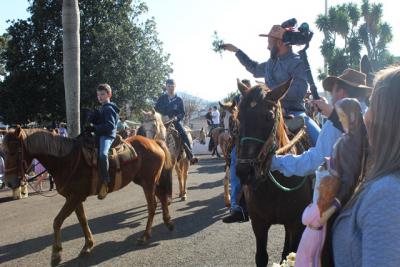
[237,100,281,175]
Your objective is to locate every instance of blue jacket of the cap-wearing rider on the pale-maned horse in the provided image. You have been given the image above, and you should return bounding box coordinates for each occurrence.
[155,94,185,121]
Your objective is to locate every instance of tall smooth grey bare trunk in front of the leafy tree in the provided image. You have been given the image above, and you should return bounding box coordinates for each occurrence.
[62,0,80,137]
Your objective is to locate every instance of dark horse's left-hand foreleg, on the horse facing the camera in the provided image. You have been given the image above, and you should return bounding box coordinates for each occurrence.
[251,220,270,267]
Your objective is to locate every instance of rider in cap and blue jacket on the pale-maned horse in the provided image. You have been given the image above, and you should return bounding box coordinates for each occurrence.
[154,79,198,164]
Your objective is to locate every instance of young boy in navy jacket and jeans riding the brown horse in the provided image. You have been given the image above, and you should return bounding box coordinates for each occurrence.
[85,83,119,199]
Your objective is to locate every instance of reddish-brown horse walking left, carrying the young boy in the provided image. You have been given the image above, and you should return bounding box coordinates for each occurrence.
[4,126,174,265]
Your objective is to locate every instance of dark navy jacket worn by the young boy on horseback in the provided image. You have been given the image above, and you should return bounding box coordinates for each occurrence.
[92,102,119,138]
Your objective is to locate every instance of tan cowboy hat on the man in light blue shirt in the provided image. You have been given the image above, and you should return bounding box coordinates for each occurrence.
[322,69,372,92]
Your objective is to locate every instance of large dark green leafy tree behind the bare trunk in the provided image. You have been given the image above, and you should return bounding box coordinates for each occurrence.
[0,0,172,122]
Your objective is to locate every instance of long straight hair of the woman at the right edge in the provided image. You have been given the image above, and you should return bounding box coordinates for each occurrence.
[367,67,400,179]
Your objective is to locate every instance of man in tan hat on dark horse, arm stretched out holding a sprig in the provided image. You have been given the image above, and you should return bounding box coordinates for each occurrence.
[223,25,321,146]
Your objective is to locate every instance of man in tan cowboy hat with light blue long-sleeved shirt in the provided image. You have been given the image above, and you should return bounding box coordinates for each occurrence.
[271,69,372,177]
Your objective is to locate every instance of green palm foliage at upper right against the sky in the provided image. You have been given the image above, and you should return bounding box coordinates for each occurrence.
[316,0,394,78]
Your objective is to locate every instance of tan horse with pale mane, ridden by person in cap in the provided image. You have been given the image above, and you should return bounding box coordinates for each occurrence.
[141,109,192,201]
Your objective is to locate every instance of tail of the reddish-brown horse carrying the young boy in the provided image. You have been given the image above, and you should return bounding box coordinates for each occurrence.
[156,140,173,203]
